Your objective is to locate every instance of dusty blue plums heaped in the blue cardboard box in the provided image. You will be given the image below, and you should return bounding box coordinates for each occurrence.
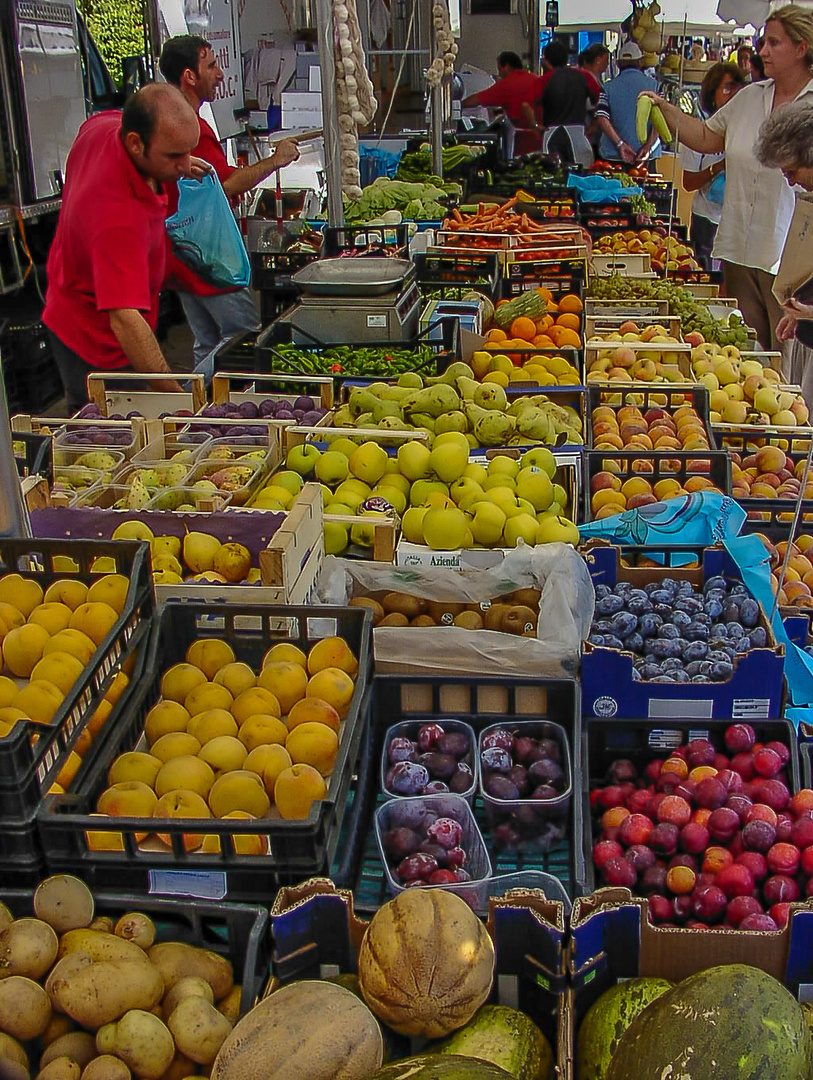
[587,577,769,683]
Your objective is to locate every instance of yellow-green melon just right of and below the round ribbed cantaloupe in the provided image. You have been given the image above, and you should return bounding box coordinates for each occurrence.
[432,1005,554,1080]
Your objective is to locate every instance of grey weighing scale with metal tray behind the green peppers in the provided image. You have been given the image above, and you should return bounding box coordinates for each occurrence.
[282,256,421,345]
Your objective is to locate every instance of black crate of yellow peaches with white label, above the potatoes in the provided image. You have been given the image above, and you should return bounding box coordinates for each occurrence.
[38,602,372,901]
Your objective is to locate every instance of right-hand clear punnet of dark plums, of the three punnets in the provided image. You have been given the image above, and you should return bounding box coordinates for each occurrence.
[479,727,570,851]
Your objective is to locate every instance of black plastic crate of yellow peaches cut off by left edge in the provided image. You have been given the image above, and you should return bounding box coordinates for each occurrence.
[0,539,154,825]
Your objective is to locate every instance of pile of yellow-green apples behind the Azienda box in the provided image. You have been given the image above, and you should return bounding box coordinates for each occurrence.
[272,432,579,555]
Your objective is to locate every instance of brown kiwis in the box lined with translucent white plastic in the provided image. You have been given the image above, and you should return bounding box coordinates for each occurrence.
[350,589,541,637]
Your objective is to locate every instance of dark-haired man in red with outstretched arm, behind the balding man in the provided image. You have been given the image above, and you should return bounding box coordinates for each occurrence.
[159,35,299,364]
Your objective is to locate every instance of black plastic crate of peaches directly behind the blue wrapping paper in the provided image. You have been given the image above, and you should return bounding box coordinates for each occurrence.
[584,449,731,522]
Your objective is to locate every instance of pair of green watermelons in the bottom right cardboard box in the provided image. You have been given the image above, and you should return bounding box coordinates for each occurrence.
[575,963,811,1080]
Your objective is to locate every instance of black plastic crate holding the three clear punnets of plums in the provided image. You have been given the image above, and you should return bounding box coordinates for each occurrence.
[334,675,584,912]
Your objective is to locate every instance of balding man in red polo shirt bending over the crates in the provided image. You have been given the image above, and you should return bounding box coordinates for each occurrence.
[42,84,203,413]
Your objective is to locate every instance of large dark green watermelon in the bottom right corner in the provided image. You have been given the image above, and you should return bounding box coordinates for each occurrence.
[607,963,812,1080]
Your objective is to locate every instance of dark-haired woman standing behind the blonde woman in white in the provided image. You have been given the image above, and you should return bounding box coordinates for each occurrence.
[680,64,745,270]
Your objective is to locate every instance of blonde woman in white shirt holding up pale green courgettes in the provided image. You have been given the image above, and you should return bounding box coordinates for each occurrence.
[645,4,813,358]
